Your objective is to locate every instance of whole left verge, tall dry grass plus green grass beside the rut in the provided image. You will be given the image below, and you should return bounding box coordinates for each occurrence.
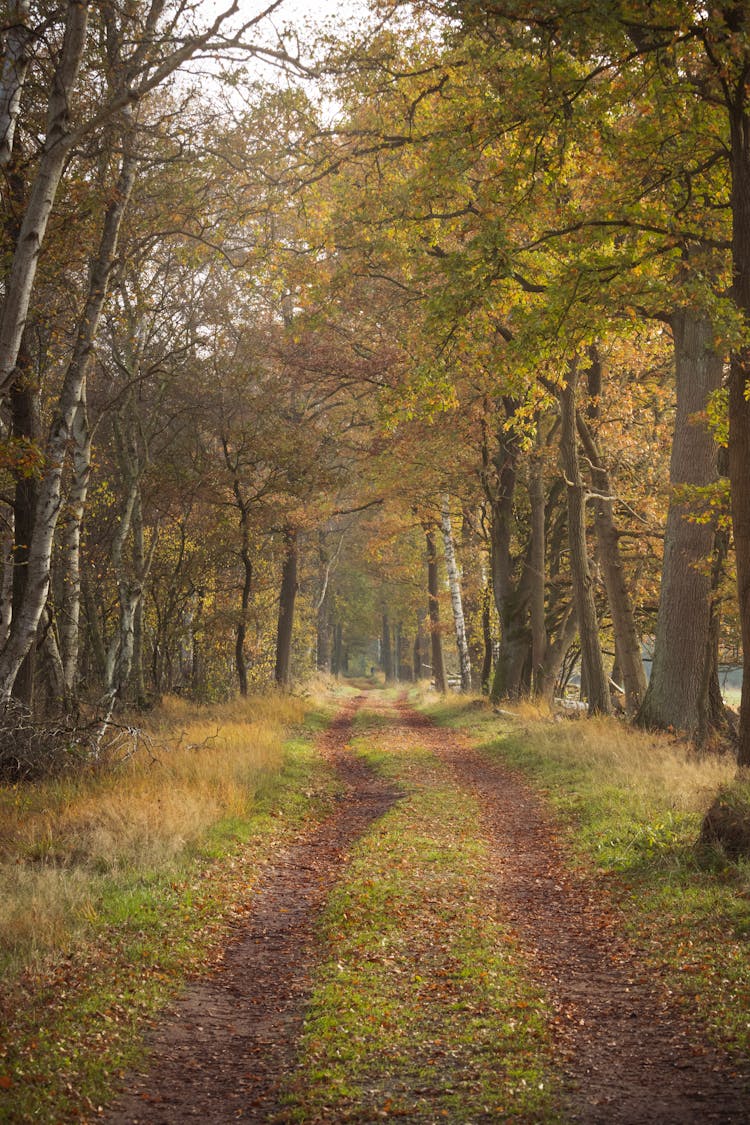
[0,699,334,1122]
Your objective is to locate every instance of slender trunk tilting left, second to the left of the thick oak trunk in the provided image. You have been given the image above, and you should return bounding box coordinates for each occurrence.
[558,360,612,714]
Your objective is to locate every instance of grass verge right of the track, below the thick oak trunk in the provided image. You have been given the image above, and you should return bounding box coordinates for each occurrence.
[427,701,750,1055]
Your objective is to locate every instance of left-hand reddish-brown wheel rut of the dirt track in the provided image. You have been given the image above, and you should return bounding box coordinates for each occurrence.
[105,699,398,1125]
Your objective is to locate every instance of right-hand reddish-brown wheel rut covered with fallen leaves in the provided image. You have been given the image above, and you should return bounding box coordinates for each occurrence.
[398,702,750,1125]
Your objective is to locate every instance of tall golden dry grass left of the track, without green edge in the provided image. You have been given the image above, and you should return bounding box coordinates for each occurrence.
[0,695,306,959]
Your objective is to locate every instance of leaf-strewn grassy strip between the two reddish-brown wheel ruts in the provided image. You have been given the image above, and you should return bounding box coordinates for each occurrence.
[283,712,557,1123]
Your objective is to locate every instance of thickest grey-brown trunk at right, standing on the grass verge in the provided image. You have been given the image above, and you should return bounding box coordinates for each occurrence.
[639,309,723,737]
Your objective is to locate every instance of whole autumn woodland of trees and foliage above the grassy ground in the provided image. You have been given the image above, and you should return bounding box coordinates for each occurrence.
[0,0,750,780]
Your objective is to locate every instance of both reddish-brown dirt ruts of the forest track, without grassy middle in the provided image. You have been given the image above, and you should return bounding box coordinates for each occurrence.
[105,692,750,1125]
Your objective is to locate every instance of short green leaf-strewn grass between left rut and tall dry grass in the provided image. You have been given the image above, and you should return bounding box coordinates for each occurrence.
[0,717,335,1122]
